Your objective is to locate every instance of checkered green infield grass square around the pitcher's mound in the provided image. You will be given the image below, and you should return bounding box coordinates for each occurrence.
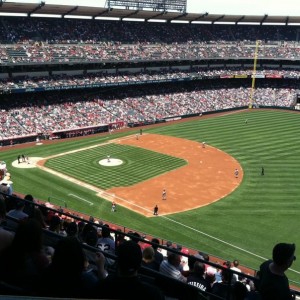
[46,144,186,189]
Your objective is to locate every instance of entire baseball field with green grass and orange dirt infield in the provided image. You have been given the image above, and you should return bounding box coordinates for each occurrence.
[0,109,300,286]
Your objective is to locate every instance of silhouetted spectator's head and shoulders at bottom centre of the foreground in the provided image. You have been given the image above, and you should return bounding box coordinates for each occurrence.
[92,240,165,300]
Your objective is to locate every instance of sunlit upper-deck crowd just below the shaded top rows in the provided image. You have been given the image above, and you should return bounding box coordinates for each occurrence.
[0,42,300,64]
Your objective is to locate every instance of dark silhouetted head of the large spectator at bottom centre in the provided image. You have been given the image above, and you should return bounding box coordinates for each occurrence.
[117,241,142,277]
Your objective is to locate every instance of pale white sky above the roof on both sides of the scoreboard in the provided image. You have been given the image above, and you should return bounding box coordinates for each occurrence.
[7,0,300,16]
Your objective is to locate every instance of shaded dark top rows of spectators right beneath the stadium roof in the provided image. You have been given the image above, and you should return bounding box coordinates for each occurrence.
[0,17,298,44]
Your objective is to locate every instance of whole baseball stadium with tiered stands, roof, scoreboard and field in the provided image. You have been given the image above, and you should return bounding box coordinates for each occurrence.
[0,0,300,300]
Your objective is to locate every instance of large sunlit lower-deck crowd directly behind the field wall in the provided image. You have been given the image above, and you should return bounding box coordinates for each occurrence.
[0,82,296,138]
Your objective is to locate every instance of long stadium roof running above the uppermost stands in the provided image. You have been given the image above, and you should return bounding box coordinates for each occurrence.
[0,0,300,25]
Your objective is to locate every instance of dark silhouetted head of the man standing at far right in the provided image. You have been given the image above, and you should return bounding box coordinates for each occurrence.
[273,243,296,269]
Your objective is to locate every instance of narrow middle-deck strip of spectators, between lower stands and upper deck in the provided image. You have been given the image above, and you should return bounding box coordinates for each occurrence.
[0,67,300,93]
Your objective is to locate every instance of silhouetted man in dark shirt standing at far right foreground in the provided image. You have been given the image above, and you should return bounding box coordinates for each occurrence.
[257,243,296,300]
